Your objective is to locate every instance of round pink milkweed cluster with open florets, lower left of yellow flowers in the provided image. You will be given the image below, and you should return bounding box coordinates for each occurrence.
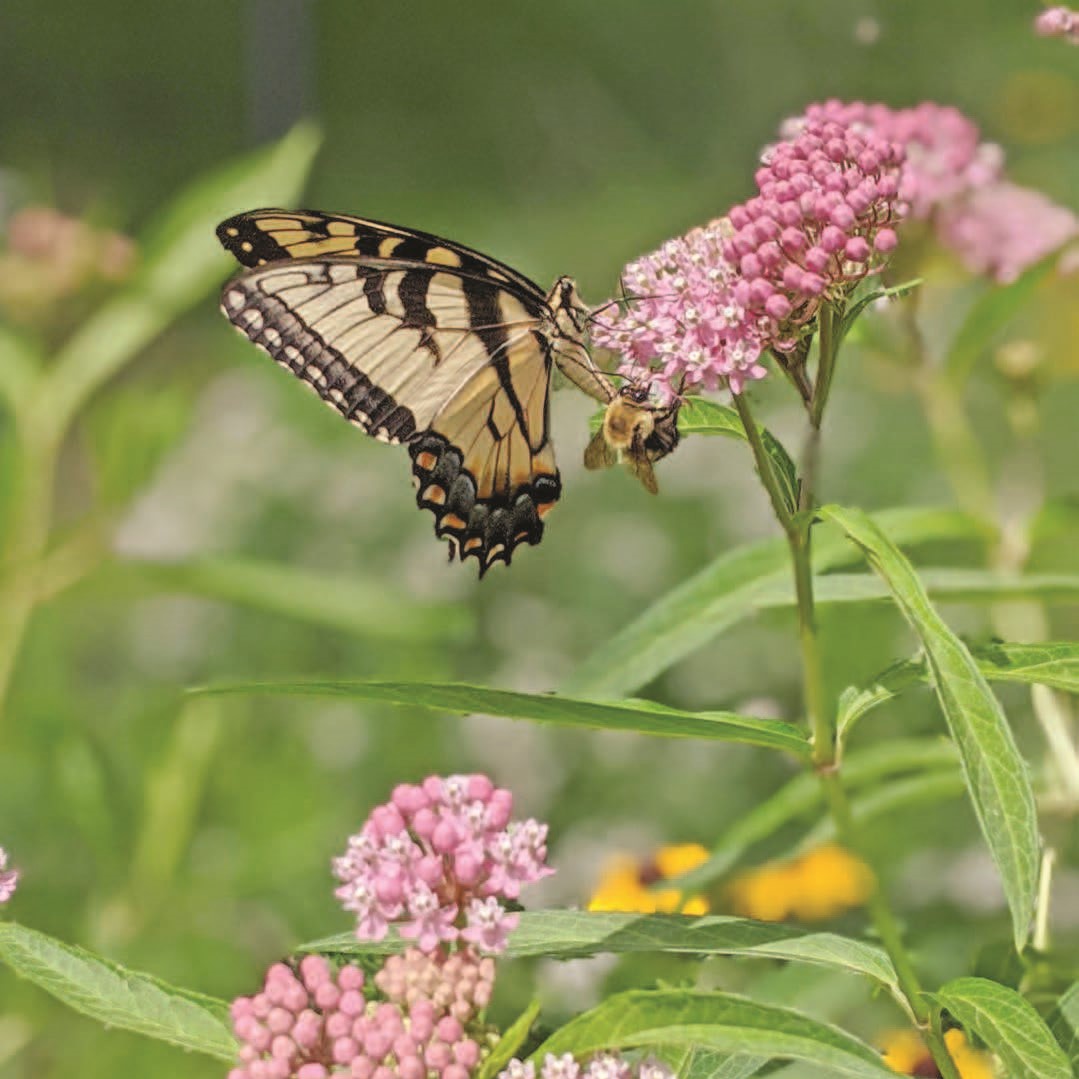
[333,775,554,953]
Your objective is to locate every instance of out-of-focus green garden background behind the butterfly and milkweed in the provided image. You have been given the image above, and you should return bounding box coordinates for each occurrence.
[0,0,1079,1079]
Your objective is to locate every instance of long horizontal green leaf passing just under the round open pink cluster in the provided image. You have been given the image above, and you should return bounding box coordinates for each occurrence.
[301,910,898,993]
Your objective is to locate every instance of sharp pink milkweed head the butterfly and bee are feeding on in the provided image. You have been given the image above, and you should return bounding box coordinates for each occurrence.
[592,101,904,396]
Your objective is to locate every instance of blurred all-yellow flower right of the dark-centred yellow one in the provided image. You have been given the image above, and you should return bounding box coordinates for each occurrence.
[727,844,875,921]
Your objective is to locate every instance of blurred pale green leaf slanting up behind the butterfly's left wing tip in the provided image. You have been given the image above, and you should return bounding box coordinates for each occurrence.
[44,123,319,431]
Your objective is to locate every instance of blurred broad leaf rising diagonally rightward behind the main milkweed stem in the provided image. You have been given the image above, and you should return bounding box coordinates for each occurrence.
[562,509,984,697]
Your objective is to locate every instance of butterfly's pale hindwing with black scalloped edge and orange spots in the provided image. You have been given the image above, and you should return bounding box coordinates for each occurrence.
[215,256,561,573]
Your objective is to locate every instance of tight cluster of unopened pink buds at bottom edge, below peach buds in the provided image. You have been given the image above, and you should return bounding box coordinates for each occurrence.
[229,955,494,1079]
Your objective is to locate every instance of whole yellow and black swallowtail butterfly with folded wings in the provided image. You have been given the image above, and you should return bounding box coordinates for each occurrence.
[217,209,677,575]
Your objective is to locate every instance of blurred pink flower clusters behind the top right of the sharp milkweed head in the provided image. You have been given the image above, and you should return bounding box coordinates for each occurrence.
[796,98,1079,284]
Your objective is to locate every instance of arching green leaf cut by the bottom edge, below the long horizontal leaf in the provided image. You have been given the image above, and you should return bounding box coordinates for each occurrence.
[532,989,896,1079]
